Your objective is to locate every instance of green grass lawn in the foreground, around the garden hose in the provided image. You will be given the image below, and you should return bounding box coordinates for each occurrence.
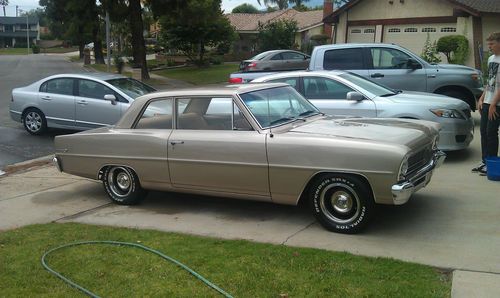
[0,223,451,297]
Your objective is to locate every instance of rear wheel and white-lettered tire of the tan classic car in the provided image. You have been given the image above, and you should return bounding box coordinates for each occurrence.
[102,166,146,205]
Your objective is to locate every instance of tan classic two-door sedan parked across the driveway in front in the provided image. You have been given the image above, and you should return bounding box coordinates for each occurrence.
[54,84,445,233]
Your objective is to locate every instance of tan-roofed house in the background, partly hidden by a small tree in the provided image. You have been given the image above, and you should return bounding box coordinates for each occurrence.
[226,9,325,52]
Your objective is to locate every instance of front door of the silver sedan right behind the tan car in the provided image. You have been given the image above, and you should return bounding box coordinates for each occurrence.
[302,76,377,117]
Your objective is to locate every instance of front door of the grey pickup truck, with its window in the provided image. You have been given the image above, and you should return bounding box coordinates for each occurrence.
[368,47,427,92]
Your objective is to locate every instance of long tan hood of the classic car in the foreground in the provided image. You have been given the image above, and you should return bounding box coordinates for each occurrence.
[290,117,440,148]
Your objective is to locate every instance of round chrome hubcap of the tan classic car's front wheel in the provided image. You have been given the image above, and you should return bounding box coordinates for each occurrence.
[320,183,361,224]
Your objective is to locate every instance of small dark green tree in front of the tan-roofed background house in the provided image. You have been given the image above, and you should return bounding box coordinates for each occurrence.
[258,20,298,51]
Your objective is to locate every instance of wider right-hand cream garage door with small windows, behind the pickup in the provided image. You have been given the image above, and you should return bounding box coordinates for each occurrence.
[384,23,457,57]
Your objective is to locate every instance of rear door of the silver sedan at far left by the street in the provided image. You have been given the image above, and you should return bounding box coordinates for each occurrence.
[38,78,75,128]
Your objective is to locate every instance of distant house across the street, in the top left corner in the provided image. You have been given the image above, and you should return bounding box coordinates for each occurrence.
[0,17,40,48]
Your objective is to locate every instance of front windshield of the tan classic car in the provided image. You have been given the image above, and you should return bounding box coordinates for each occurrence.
[240,86,320,128]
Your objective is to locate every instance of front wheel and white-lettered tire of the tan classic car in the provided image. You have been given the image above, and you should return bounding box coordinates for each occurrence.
[309,174,375,234]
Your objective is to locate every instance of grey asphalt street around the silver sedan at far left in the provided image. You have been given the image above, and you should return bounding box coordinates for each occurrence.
[0,54,85,170]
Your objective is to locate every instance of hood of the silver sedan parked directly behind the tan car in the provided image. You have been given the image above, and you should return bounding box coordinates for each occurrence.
[385,91,469,110]
